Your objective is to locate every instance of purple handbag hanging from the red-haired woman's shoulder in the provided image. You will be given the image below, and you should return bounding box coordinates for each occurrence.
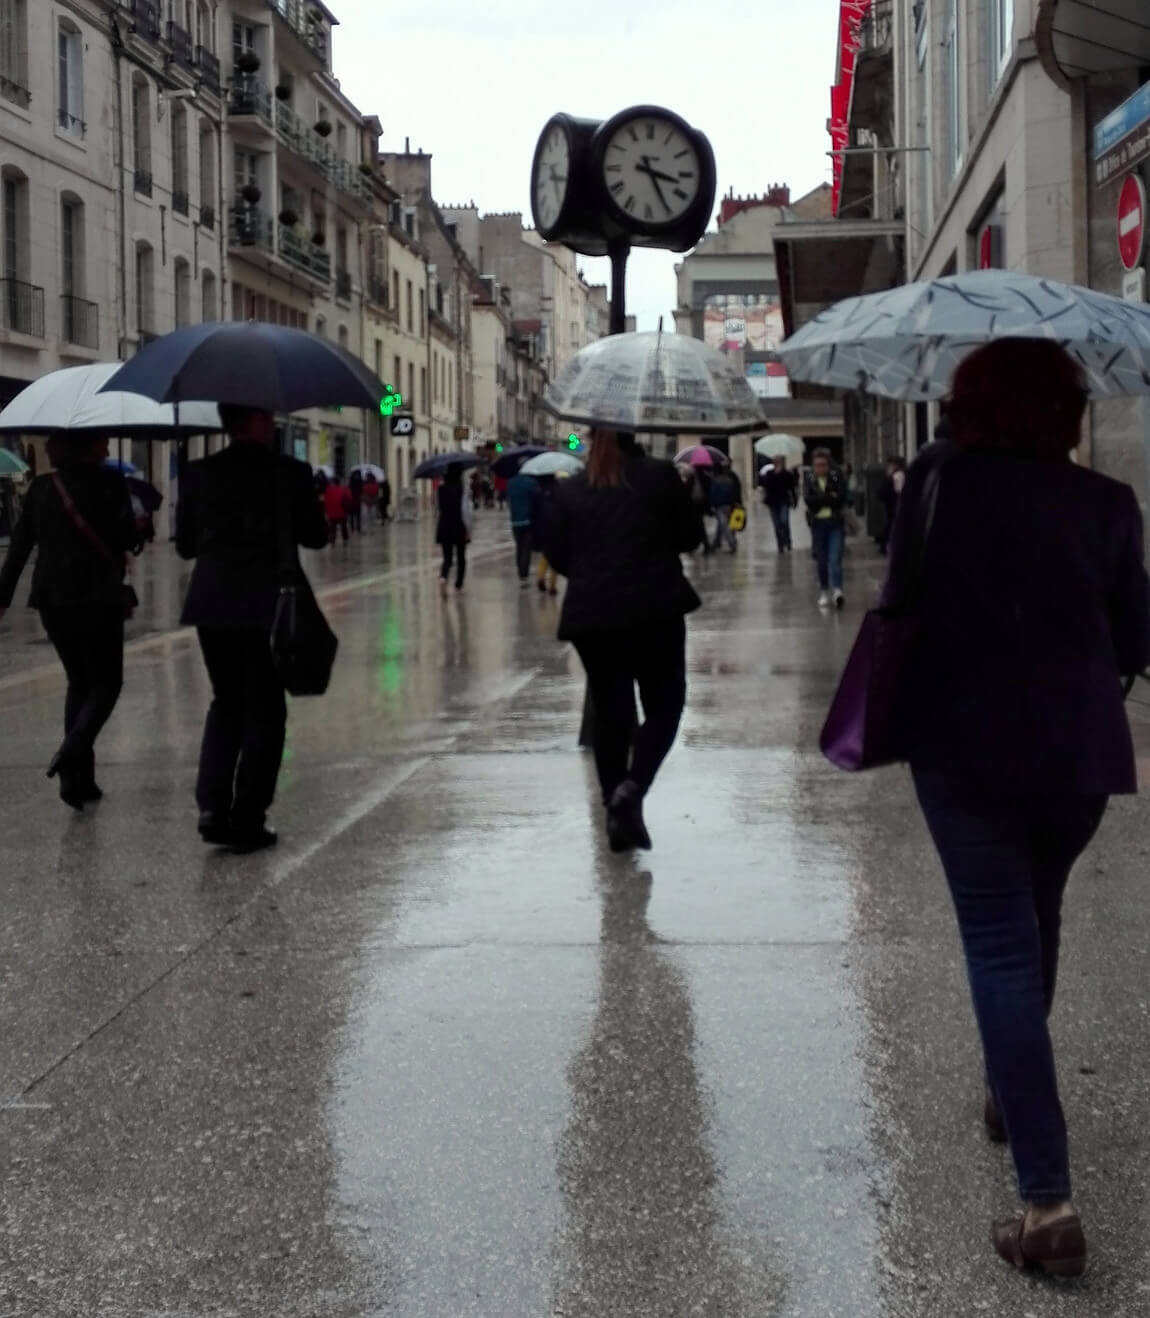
[818,461,942,772]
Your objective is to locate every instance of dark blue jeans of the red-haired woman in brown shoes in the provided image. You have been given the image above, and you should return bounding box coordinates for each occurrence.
[914,767,1107,1201]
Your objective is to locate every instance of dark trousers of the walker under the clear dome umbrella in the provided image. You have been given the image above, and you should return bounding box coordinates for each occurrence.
[574,618,686,801]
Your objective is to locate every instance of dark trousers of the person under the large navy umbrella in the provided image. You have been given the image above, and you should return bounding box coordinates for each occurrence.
[196,627,287,828]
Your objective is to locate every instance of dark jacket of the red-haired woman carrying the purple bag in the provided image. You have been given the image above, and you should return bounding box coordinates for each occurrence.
[885,444,1150,797]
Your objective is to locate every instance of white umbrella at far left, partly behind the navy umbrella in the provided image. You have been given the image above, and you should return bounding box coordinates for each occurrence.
[0,361,224,439]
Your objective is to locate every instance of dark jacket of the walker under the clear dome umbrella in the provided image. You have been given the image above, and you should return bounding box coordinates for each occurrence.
[544,448,703,641]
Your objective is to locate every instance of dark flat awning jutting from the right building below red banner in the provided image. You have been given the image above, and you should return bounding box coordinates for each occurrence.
[775,219,906,335]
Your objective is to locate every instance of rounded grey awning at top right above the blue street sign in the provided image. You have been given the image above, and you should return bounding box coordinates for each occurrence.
[1034,0,1150,87]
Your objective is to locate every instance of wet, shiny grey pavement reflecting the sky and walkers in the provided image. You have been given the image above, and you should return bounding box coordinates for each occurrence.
[0,509,1150,1318]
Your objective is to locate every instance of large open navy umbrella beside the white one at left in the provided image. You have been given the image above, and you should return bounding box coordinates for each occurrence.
[101,320,386,413]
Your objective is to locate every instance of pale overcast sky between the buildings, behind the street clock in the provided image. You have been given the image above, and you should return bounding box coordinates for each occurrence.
[329,0,839,330]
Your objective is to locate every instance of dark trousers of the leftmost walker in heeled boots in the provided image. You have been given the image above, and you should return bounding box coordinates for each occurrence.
[40,604,124,783]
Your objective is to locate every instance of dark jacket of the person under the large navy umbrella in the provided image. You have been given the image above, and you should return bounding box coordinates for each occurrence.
[175,443,328,631]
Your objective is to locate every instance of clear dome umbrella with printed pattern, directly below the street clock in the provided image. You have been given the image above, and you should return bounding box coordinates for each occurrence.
[543,330,767,435]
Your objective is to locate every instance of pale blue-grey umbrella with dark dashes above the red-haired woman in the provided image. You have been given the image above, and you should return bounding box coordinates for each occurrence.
[779,270,1150,402]
